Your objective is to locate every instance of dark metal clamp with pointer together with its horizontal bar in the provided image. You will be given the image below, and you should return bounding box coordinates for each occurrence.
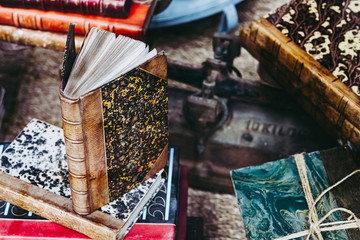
[168,26,300,156]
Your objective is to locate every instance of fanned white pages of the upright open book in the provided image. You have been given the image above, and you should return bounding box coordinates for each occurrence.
[64,28,157,99]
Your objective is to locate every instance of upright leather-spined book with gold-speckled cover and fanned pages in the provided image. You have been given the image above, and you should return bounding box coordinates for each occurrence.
[59,23,168,214]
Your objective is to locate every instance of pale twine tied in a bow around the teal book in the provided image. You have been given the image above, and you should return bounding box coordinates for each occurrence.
[276,153,360,240]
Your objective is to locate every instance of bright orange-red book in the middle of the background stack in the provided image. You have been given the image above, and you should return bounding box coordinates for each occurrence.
[0,4,153,39]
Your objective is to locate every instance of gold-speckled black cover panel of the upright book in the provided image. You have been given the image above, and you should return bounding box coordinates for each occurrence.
[101,68,168,201]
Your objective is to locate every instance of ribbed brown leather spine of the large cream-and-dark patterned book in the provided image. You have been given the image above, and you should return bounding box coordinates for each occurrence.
[240,18,360,146]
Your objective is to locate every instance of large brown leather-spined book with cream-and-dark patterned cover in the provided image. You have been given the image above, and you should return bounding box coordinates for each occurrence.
[240,0,360,146]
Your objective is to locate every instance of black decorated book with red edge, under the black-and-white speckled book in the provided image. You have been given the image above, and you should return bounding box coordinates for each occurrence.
[0,144,188,240]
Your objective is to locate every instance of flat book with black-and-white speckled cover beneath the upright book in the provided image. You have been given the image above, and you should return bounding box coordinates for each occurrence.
[0,119,164,240]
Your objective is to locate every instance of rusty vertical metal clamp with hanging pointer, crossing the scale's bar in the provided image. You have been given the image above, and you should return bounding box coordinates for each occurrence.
[183,31,240,155]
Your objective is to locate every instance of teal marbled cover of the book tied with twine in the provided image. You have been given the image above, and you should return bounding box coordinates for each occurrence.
[231,152,348,240]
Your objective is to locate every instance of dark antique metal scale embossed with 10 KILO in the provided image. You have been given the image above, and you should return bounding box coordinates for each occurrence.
[168,18,336,192]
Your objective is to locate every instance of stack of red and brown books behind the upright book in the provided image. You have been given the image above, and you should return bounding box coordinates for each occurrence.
[0,0,157,51]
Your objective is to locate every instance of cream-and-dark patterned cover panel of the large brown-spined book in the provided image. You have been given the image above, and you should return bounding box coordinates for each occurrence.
[267,0,360,96]
